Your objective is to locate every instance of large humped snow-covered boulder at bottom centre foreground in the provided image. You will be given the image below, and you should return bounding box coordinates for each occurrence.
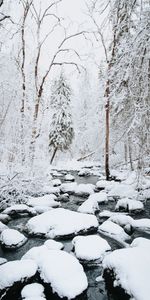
[22,246,88,299]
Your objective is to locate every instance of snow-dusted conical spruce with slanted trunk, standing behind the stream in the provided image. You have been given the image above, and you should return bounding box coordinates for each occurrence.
[49,72,74,163]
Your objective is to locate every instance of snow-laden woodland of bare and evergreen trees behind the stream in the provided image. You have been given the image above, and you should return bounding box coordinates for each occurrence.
[0,0,150,179]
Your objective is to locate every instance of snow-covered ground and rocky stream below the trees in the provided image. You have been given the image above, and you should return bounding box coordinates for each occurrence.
[0,165,150,300]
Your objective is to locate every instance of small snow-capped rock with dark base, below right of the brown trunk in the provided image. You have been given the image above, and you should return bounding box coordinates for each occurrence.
[115,198,144,211]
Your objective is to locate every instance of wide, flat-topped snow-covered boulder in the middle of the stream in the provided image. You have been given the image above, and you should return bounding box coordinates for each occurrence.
[27,208,98,238]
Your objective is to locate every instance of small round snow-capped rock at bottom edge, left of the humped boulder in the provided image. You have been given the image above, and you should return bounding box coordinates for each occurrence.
[21,283,44,299]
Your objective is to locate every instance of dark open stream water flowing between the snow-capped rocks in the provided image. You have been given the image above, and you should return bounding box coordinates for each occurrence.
[0,172,150,300]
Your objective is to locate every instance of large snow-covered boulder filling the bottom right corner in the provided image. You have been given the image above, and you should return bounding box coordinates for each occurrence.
[103,247,150,300]
